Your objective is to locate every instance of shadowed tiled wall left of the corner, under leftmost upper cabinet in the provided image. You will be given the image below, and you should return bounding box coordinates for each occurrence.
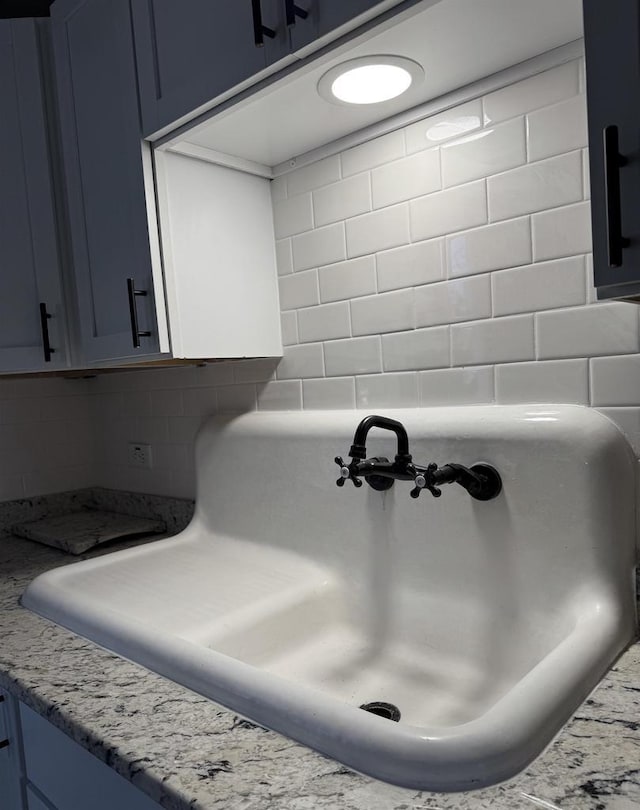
[0,378,95,501]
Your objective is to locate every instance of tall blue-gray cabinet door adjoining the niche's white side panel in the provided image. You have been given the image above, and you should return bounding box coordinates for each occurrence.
[52,0,164,362]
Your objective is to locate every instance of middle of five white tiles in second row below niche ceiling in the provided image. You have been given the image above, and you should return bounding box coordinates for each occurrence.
[371,149,441,208]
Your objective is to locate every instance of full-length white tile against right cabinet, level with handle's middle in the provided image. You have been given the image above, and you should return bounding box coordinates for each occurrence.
[487,152,582,222]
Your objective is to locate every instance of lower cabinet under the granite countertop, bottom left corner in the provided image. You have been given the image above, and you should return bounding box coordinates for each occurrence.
[0,691,160,810]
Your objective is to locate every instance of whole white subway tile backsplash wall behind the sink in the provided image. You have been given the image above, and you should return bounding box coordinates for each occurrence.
[5,52,640,496]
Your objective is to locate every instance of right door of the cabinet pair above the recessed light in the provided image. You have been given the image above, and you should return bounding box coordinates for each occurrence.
[288,0,389,51]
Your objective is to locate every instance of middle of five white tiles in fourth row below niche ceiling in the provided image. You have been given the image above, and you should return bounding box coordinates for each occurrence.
[376,239,444,292]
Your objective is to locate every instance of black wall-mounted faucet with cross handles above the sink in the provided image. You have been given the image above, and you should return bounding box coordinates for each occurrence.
[335,415,502,501]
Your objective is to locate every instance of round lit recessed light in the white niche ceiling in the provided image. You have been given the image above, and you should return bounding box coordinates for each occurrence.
[318,55,424,105]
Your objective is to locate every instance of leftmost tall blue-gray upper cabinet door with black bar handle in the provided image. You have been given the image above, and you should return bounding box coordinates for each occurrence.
[0,19,67,372]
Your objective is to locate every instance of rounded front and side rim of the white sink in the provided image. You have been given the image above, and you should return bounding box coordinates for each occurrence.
[21,529,633,792]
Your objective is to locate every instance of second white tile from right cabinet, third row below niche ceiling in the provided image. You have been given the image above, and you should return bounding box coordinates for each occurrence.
[409,180,487,242]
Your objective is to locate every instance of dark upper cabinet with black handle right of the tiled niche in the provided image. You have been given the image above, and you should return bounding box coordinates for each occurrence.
[583,0,640,301]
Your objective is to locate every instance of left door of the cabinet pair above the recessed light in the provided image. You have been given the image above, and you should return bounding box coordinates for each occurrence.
[132,0,289,136]
